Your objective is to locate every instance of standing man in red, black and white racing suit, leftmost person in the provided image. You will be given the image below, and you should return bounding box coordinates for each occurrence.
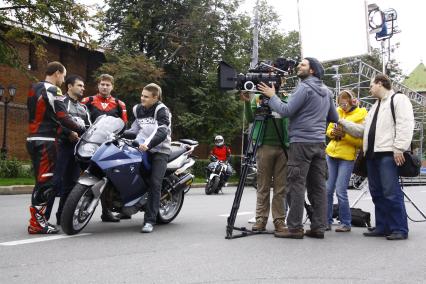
[27,62,85,234]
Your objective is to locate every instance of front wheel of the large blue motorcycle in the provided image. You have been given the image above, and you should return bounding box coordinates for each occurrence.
[61,184,95,235]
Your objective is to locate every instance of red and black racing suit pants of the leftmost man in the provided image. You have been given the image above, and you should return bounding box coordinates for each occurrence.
[27,140,56,206]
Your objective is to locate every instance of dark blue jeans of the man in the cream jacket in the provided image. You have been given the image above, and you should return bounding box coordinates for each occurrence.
[367,153,408,235]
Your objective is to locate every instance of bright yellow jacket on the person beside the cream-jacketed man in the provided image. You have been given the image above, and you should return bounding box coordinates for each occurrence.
[325,107,367,161]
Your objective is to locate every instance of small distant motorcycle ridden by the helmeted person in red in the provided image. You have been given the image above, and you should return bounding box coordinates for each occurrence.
[205,156,229,195]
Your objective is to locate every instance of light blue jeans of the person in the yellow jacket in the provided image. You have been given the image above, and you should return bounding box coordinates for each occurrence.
[327,155,354,227]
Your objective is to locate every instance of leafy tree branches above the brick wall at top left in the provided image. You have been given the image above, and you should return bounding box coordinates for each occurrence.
[0,0,93,70]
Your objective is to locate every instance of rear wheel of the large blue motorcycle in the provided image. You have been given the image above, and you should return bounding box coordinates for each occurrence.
[157,190,184,224]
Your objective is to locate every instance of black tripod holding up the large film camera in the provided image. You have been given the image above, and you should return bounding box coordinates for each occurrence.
[225,107,288,239]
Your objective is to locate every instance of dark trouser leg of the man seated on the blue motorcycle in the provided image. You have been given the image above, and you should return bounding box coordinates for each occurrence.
[145,153,169,224]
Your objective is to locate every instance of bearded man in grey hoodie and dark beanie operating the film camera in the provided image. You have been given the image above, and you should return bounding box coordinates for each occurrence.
[257,57,339,239]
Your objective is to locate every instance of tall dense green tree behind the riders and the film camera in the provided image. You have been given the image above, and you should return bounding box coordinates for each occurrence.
[100,0,298,142]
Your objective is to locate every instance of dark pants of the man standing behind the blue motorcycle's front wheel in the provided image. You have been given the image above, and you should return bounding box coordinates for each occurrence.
[46,143,81,219]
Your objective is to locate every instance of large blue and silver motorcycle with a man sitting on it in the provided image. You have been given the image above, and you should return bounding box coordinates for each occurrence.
[61,115,198,235]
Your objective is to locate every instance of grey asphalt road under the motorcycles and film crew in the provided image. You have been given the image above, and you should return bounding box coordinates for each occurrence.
[0,187,426,283]
